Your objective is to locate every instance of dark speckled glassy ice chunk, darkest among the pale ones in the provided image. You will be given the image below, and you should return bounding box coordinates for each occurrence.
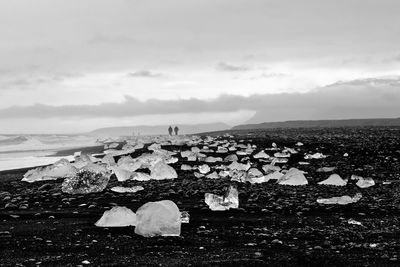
[61,170,110,194]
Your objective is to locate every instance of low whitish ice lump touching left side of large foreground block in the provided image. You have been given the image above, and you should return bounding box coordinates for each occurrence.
[95,206,136,227]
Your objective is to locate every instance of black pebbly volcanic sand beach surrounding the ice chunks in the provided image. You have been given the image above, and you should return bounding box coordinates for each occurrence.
[0,128,400,266]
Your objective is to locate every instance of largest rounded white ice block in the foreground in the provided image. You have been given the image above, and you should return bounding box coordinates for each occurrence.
[135,200,181,237]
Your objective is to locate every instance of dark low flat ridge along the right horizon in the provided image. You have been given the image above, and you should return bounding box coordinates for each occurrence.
[232,118,400,130]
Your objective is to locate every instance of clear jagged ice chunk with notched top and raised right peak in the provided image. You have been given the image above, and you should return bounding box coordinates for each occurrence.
[204,186,239,211]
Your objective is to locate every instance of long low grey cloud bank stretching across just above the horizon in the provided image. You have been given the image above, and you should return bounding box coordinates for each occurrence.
[0,78,400,122]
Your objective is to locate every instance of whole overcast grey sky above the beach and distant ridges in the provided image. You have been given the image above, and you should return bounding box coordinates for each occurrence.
[0,0,400,133]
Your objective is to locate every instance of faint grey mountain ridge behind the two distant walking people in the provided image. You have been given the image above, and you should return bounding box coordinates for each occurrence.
[89,123,231,136]
